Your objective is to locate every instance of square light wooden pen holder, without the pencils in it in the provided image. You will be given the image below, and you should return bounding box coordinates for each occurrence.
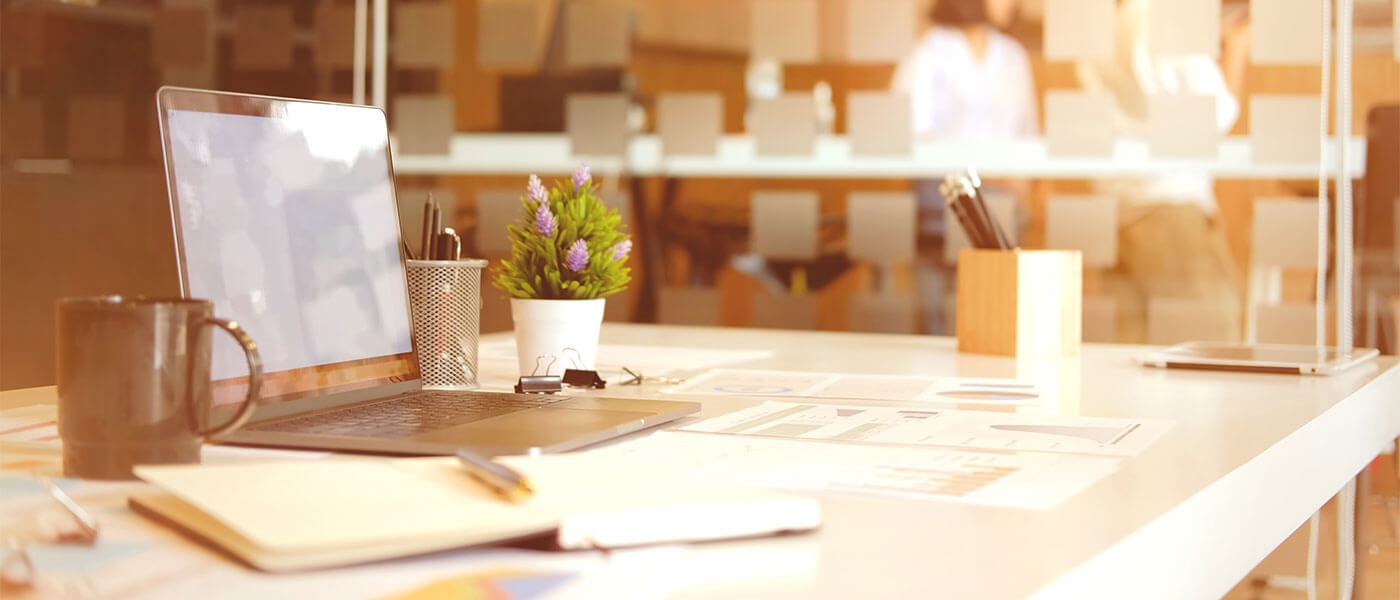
[958,249,1084,357]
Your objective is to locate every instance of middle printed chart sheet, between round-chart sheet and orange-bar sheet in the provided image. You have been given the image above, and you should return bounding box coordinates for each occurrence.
[680,401,1172,456]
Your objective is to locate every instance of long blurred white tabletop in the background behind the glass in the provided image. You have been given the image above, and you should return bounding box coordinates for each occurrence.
[391,133,1366,179]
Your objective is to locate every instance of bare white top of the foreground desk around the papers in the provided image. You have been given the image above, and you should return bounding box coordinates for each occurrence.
[0,324,1400,599]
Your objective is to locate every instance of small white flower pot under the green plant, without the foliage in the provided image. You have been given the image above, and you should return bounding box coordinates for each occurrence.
[511,298,606,376]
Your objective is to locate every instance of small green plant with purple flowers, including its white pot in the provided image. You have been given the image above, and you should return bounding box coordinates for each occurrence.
[494,162,631,375]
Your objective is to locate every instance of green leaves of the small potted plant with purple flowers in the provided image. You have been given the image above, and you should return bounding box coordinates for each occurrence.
[494,182,631,299]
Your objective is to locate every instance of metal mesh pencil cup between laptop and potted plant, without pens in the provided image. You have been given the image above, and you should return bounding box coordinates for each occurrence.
[406,260,486,390]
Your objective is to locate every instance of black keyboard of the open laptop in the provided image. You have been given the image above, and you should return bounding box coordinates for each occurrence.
[245,392,567,438]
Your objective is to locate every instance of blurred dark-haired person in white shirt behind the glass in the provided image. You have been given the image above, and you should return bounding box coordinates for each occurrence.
[892,0,1040,334]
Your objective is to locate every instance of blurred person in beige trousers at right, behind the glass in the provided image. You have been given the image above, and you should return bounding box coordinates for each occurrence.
[1075,0,1249,343]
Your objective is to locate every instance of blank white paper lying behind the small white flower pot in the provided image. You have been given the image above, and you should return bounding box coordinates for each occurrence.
[477,338,773,376]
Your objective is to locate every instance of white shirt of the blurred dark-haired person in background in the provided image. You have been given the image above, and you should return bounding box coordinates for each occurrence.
[893,27,1040,140]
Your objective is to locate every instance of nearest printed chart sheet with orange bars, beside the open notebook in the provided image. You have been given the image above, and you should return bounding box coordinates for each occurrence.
[595,432,1121,510]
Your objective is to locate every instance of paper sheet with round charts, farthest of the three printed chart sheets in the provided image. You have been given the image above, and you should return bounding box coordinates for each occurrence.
[665,369,1054,406]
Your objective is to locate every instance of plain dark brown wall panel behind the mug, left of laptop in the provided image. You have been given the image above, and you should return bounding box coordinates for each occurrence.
[0,168,179,389]
